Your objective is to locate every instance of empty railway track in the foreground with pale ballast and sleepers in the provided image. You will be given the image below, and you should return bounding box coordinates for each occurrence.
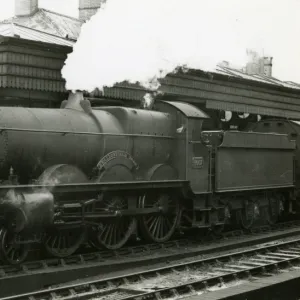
[7,239,300,300]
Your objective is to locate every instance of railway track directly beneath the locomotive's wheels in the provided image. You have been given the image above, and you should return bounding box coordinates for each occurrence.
[0,221,300,278]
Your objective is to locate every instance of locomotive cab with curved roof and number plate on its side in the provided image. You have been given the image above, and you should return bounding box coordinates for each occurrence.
[156,101,212,194]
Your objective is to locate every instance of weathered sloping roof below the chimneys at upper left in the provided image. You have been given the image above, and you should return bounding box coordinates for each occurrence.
[0,8,83,40]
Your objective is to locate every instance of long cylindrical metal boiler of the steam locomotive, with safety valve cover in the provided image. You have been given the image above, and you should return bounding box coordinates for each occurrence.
[0,94,172,183]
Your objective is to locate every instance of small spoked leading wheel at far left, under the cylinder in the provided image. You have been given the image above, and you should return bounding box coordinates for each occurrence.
[0,228,30,265]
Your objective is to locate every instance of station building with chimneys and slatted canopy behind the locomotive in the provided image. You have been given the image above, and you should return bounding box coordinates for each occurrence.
[0,0,300,125]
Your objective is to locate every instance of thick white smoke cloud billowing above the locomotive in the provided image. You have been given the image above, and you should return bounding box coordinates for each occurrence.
[62,0,251,92]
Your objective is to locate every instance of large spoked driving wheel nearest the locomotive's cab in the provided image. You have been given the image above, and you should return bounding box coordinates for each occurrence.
[139,194,181,243]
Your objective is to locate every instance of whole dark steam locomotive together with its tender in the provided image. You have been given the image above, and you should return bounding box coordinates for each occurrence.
[0,93,299,264]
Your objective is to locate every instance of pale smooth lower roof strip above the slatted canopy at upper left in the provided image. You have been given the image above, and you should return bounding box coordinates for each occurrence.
[0,23,75,47]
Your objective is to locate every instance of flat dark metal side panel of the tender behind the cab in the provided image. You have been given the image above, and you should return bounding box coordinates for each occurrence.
[215,132,295,192]
